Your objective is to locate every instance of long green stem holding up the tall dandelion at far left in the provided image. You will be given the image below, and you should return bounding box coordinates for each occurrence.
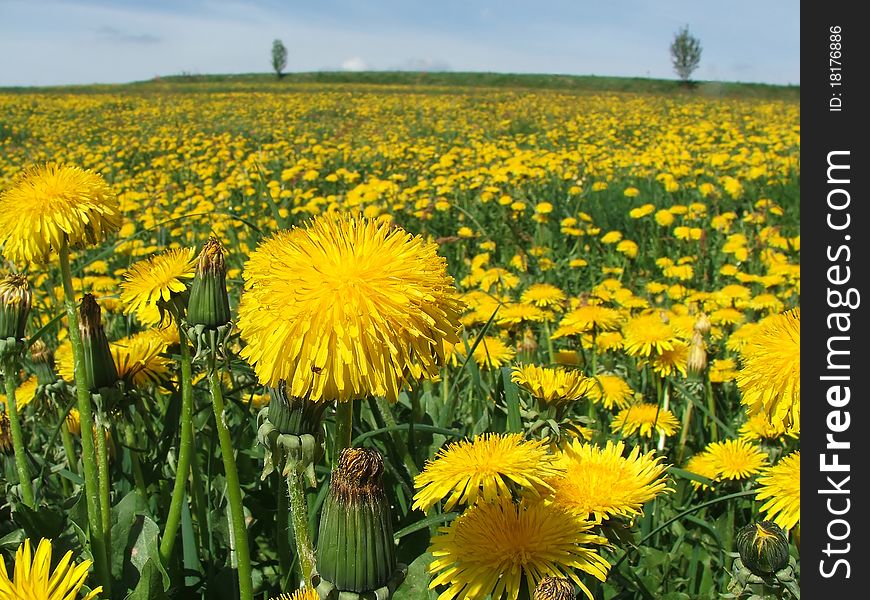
[60,240,112,597]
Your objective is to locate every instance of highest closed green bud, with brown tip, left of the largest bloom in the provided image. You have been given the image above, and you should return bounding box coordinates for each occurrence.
[187,236,232,356]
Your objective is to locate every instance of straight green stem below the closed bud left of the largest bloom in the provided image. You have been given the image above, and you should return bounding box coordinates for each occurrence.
[208,352,254,600]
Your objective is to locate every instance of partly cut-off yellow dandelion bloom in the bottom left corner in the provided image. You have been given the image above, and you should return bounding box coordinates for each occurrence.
[0,539,103,600]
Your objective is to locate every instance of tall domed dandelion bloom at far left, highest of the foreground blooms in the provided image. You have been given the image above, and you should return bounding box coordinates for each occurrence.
[0,163,121,263]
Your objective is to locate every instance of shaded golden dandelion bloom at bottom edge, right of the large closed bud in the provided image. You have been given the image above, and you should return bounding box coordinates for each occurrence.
[429,498,610,600]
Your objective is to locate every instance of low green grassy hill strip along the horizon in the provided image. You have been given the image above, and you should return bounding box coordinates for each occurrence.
[0,71,800,100]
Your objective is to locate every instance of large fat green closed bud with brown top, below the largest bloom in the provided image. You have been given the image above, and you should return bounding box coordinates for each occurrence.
[313,448,406,598]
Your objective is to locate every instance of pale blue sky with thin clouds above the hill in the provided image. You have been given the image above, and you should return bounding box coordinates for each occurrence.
[0,0,800,86]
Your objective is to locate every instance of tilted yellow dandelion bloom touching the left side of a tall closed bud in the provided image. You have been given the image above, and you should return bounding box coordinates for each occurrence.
[121,248,197,325]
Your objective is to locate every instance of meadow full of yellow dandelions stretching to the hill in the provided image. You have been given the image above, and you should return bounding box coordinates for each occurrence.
[0,84,800,600]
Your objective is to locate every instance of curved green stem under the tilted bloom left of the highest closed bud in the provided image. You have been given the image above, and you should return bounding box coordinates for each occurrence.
[160,311,193,565]
